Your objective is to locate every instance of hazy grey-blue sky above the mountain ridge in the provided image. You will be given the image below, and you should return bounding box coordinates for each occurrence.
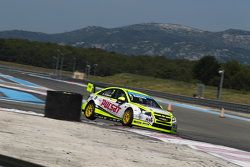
[0,0,250,33]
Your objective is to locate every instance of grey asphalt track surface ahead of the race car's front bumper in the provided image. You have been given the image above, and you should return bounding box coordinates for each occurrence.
[173,106,250,151]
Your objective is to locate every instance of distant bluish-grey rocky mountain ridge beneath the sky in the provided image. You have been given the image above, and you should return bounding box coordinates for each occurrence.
[0,23,250,64]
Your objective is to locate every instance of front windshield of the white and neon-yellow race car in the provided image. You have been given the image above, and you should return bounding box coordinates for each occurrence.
[128,91,161,108]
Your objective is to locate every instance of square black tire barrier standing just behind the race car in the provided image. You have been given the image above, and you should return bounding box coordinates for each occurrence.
[45,91,82,121]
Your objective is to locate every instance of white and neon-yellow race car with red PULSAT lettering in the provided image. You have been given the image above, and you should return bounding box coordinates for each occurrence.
[82,84,177,134]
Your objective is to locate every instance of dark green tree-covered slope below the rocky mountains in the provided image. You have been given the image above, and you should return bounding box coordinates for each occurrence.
[0,39,250,90]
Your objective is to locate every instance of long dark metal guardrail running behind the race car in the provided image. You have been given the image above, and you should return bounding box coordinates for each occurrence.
[80,80,250,114]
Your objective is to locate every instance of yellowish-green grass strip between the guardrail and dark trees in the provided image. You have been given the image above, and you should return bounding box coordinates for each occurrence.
[91,73,250,104]
